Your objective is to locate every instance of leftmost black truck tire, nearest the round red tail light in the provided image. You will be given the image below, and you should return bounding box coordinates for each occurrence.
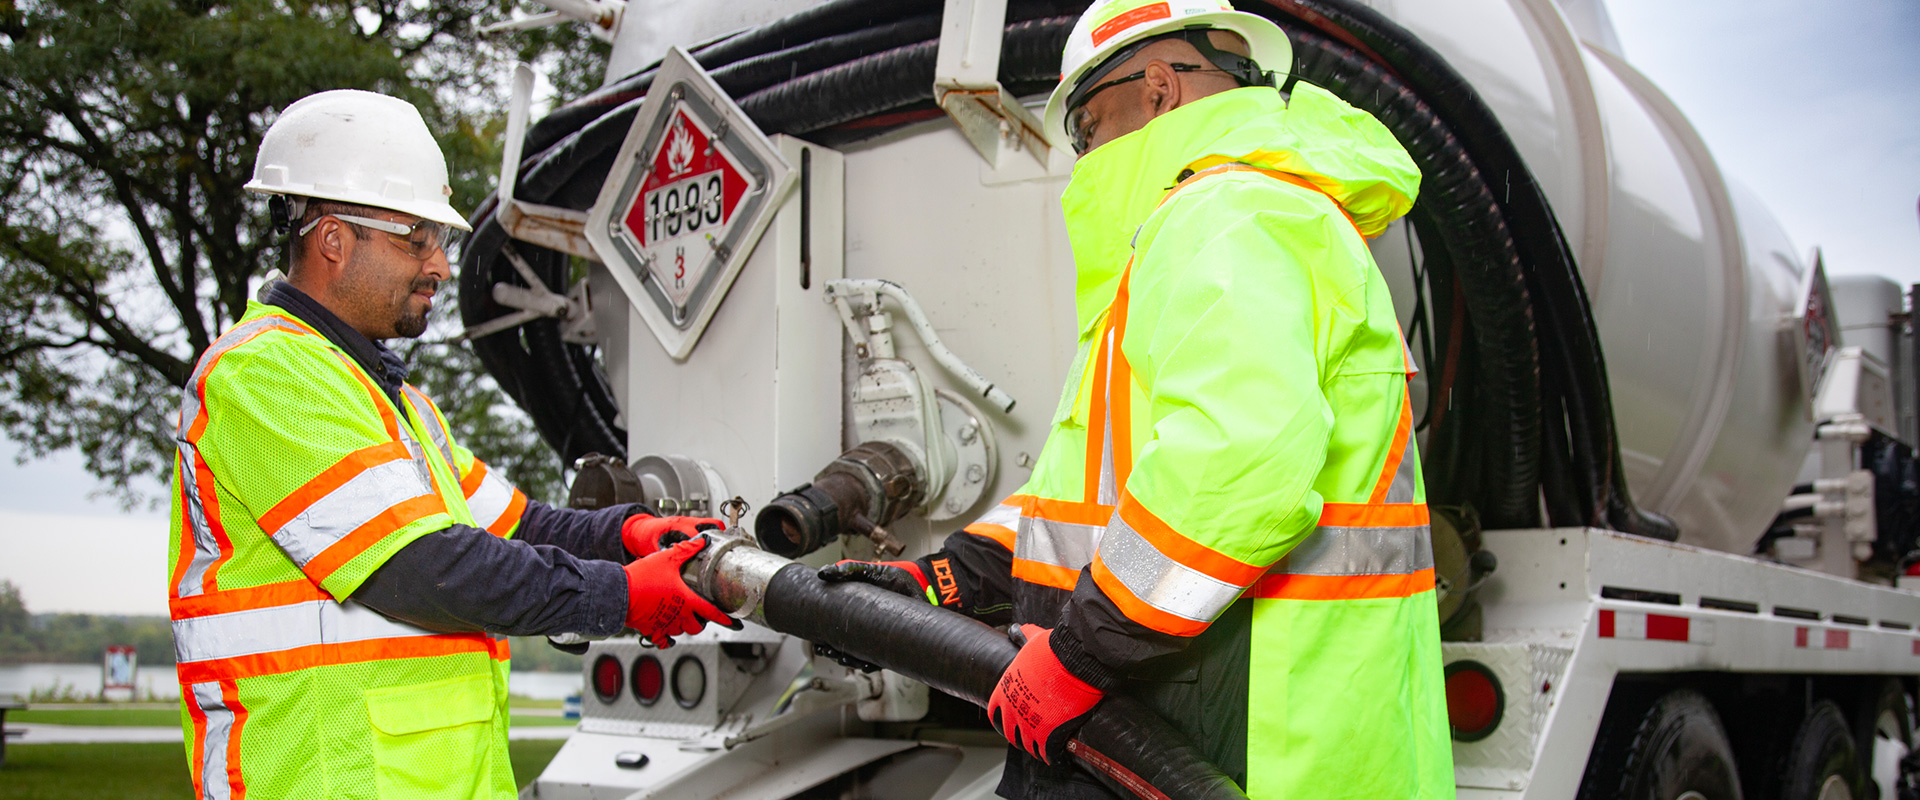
[1580,689,1751,800]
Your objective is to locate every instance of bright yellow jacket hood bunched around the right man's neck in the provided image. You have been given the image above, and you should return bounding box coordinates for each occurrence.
[1060,82,1421,332]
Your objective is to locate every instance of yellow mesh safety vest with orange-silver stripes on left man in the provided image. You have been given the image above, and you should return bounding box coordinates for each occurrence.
[169,295,528,800]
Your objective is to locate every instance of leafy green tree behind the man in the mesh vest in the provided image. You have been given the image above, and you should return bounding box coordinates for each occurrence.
[0,0,605,505]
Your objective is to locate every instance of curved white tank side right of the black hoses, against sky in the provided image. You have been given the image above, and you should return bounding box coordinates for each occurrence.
[1379,0,1812,553]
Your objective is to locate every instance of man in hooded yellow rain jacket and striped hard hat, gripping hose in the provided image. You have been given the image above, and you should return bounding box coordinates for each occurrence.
[822,0,1453,800]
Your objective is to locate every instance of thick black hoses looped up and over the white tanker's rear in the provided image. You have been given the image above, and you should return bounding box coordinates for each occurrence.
[461,0,1672,502]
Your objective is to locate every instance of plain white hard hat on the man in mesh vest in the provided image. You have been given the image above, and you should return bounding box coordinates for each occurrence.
[246,88,472,230]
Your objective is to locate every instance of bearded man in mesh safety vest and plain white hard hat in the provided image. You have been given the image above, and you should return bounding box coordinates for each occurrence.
[167,90,732,800]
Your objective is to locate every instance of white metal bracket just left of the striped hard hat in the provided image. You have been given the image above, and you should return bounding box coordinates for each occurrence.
[933,0,1052,167]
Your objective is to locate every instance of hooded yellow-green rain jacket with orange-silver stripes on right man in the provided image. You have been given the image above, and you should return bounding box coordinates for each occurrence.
[968,82,1453,800]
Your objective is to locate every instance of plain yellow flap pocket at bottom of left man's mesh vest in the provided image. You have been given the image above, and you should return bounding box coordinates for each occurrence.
[367,675,493,800]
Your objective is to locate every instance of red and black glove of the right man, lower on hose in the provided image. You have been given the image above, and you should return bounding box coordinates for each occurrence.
[987,625,1106,764]
